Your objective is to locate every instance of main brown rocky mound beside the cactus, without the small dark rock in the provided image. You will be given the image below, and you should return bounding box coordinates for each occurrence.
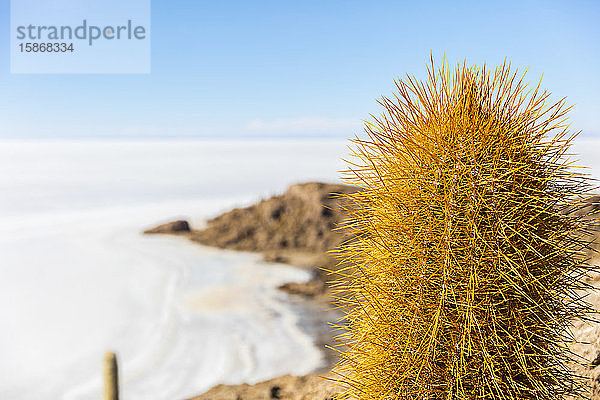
[190,182,357,254]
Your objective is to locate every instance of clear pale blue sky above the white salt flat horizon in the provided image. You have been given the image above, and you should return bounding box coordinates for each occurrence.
[0,0,600,139]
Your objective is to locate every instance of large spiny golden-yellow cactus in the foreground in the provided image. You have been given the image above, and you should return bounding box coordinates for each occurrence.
[334,60,592,400]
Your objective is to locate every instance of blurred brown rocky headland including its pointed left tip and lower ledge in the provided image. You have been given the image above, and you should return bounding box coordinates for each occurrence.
[144,182,358,301]
